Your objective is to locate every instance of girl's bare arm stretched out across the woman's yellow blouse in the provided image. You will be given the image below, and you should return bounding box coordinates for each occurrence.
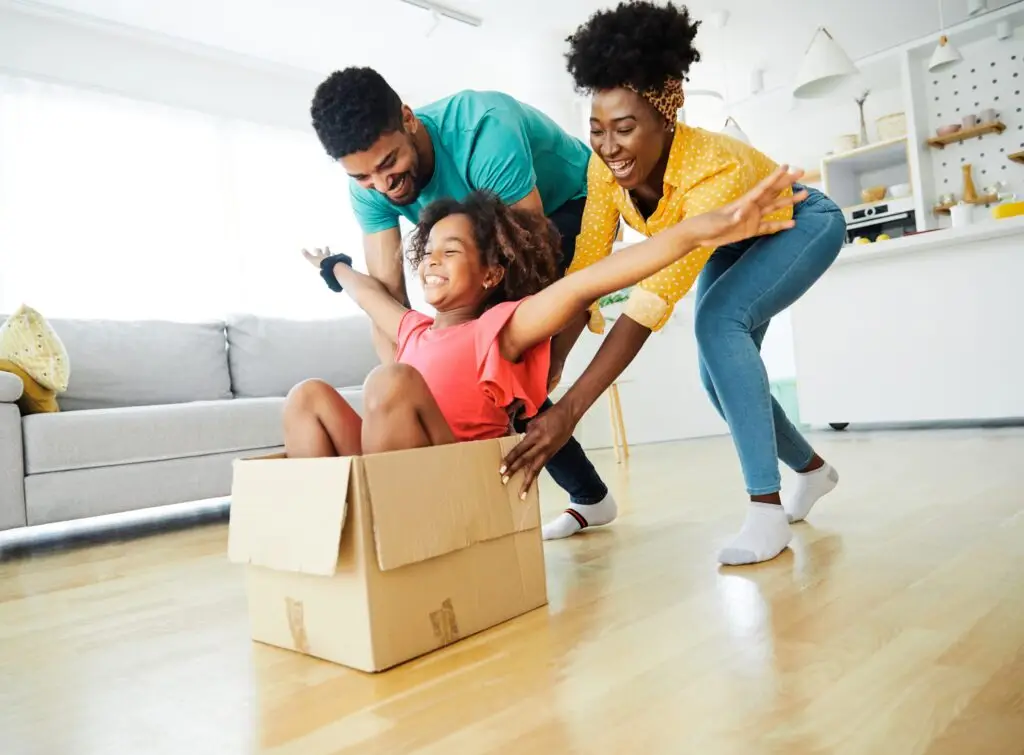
[500,165,807,362]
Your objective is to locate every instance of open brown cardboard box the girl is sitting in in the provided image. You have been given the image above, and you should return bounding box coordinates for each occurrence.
[228,437,548,671]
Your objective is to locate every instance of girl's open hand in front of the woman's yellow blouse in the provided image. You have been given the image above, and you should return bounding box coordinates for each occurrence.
[684,165,807,248]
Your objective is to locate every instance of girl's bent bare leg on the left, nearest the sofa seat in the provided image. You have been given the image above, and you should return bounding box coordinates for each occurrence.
[285,380,362,459]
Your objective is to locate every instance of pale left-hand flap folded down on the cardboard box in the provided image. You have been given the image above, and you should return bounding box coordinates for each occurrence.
[227,457,352,576]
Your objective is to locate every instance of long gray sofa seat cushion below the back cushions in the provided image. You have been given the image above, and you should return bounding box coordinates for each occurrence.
[23,399,285,474]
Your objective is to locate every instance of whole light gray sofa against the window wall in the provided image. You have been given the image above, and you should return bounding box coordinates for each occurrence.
[0,316,378,530]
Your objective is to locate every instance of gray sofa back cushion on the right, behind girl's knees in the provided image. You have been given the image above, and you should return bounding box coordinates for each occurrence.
[227,314,379,397]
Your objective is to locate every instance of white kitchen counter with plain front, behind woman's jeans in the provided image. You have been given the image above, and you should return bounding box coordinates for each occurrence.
[791,217,1024,426]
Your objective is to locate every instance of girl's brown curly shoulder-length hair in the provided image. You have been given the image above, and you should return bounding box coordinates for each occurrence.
[408,191,561,309]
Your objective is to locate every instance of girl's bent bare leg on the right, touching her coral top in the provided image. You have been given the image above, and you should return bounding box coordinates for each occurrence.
[362,364,455,454]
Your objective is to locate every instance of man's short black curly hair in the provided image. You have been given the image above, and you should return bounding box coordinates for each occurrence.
[309,67,401,160]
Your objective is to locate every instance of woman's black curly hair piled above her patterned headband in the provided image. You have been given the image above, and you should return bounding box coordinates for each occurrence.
[565,0,700,92]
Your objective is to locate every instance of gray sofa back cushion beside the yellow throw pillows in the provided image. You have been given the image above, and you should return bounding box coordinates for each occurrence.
[50,320,231,410]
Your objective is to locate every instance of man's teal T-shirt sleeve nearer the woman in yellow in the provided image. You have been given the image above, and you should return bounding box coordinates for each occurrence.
[469,114,537,205]
